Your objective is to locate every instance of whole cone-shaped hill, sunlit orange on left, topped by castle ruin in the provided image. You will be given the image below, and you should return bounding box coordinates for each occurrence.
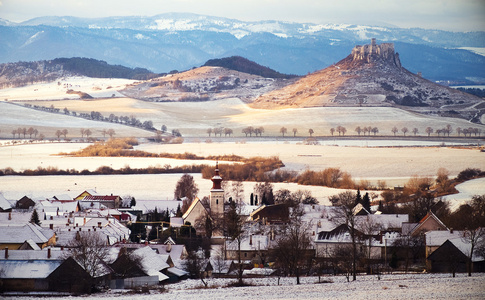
[251,39,485,122]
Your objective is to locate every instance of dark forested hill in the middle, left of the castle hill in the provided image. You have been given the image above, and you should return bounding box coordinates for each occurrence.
[204,56,297,79]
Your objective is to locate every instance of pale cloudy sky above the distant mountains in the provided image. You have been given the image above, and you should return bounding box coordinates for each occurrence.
[0,0,485,31]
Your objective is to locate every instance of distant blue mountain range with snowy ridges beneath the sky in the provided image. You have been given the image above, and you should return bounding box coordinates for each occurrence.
[0,14,485,84]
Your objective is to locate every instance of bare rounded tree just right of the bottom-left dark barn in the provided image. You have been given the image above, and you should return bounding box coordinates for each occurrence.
[64,231,109,278]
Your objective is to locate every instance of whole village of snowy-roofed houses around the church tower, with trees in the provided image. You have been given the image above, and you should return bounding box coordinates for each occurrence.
[0,164,485,295]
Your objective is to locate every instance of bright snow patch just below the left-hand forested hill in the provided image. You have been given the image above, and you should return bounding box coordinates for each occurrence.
[0,77,136,101]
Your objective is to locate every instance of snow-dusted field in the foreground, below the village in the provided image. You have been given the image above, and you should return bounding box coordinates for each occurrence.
[6,274,485,300]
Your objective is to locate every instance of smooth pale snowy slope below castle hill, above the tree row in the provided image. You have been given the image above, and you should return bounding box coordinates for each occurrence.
[8,98,485,137]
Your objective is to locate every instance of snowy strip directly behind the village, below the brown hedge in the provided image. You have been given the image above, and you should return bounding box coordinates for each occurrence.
[0,174,345,210]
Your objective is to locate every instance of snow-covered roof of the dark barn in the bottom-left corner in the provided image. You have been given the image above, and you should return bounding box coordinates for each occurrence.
[0,260,62,279]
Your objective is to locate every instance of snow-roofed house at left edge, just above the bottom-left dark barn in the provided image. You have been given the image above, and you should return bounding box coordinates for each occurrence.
[0,223,56,250]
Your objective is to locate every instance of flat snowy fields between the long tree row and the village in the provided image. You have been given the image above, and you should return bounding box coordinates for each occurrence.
[0,143,485,204]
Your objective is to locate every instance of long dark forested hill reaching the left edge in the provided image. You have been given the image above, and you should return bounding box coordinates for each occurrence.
[0,57,157,87]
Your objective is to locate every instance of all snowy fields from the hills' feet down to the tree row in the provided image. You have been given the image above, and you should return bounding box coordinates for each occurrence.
[0,77,485,138]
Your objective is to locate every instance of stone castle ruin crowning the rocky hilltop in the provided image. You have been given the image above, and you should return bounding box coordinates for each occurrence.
[352,38,401,68]
